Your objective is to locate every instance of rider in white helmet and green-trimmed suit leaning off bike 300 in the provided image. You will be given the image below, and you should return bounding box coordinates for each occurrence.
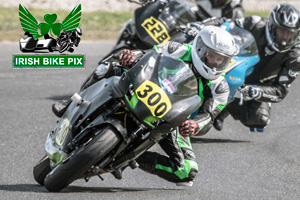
[132,26,238,186]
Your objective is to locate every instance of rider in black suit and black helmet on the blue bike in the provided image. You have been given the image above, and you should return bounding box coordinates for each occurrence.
[198,4,300,131]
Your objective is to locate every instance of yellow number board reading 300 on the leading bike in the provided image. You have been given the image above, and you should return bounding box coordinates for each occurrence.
[136,80,172,118]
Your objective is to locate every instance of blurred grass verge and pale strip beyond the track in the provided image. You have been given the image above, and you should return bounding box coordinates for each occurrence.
[0,0,300,42]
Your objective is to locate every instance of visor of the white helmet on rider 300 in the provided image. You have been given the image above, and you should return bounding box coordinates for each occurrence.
[199,48,231,73]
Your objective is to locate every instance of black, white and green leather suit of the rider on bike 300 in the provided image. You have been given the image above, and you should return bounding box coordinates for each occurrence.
[137,41,229,183]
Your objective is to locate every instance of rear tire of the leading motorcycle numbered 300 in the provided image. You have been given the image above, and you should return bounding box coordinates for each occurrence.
[33,155,51,185]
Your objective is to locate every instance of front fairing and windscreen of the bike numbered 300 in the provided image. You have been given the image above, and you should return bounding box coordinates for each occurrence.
[128,51,201,126]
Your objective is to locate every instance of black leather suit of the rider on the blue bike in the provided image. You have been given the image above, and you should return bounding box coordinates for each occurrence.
[213,16,300,128]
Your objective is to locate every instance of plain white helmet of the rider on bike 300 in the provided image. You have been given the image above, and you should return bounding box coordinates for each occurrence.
[192,26,238,80]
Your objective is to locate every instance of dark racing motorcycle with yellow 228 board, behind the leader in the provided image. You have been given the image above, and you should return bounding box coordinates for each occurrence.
[101,0,196,58]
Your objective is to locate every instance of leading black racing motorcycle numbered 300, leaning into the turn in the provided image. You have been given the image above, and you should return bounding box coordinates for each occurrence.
[33,50,201,192]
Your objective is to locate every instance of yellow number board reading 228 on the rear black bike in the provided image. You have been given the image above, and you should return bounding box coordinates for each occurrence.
[142,16,170,44]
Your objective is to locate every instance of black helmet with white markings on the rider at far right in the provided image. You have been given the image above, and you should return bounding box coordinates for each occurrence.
[266,4,300,52]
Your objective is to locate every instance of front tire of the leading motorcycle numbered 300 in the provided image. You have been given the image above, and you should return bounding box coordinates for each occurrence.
[44,126,121,192]
